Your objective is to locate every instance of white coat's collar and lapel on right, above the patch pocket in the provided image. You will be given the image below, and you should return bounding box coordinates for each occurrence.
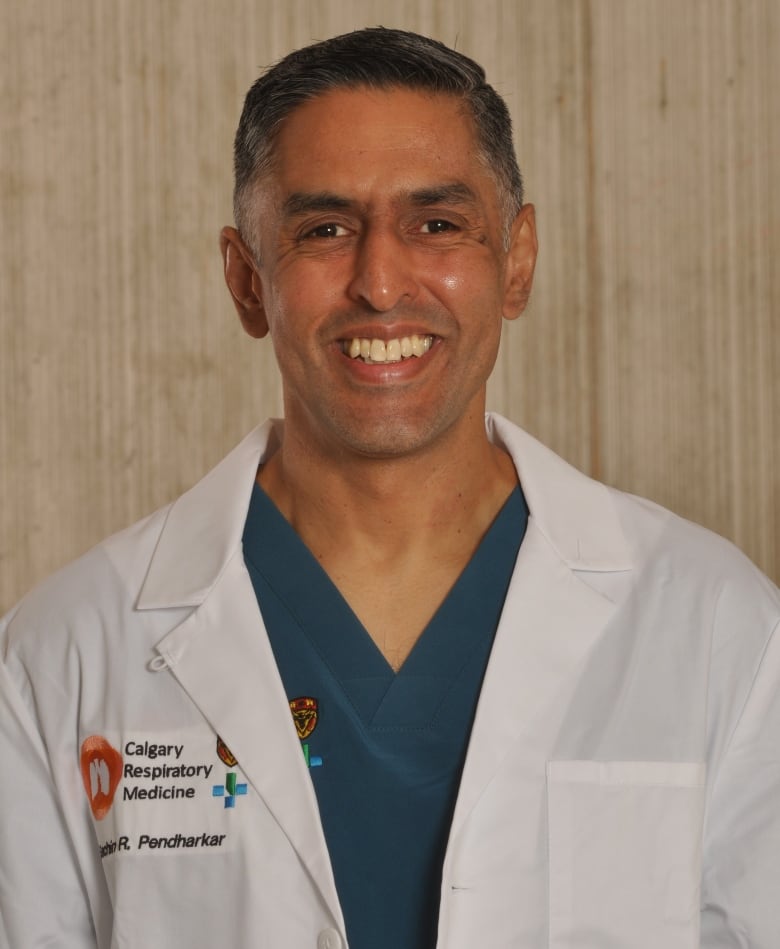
[452,416,632,837]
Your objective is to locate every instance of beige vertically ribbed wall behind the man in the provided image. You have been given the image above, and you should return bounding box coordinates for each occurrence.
[0,0,780,608]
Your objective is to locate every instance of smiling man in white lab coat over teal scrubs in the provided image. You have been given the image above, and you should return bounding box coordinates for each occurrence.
[0,29,780,949]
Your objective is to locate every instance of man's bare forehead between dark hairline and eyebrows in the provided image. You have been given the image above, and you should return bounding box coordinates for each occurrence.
[261,88,493,199]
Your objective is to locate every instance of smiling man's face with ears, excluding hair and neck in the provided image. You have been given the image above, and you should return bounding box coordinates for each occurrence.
[222,83,536,457]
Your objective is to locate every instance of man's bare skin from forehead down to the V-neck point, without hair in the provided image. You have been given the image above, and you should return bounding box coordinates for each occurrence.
[222,81,536,668]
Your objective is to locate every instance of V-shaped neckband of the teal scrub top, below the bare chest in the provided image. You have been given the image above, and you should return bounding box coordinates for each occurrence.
[244,485,528,728]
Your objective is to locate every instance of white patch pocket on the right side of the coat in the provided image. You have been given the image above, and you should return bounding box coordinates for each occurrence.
[547,761,705,949]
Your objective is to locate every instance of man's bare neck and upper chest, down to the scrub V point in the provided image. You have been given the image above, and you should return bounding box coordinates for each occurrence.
[258,413,517,669]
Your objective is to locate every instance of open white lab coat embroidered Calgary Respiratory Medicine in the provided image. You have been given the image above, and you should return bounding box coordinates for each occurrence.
[0,417,780,949]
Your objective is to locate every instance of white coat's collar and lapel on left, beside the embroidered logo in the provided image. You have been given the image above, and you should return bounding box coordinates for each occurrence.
[136,422,341,921]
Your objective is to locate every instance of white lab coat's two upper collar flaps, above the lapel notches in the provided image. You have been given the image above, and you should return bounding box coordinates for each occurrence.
[136,414,631,610]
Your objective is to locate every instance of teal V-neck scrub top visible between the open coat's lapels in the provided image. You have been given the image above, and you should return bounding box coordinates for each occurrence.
[243,485,528,949]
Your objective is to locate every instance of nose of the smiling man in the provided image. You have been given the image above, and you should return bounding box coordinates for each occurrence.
[349,228,419,313]
